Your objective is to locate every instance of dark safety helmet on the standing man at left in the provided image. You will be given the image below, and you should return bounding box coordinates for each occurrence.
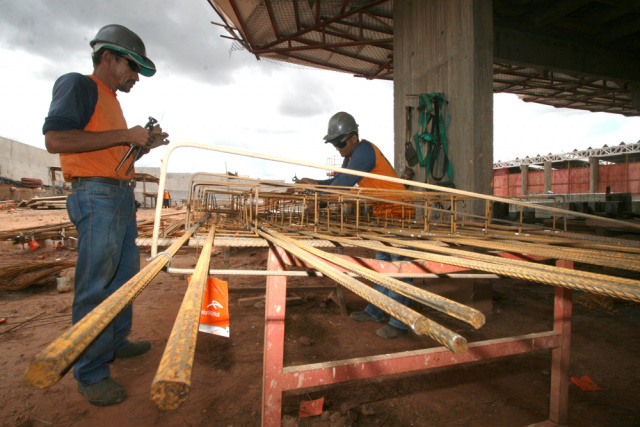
[89,24,156,77]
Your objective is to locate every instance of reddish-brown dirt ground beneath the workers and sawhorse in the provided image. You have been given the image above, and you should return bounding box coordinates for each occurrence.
[0,206,640,427]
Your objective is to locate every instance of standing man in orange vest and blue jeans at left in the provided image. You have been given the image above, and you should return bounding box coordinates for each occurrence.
[42,25,168,406]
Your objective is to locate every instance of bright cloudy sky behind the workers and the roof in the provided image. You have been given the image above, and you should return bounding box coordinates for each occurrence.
[0,0,640,182]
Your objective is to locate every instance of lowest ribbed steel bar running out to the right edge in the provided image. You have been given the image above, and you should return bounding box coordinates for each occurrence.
[312,236,640,302]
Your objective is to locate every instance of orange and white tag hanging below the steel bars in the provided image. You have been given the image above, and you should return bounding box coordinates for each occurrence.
[198,278,229,338]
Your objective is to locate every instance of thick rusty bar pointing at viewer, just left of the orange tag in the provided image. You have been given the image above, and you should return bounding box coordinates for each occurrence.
[151,221,216,411]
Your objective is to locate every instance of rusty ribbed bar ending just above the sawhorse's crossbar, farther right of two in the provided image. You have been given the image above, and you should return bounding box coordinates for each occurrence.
[262,227,485,329]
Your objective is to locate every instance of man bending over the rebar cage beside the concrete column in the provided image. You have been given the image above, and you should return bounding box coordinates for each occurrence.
[298,112,414,339]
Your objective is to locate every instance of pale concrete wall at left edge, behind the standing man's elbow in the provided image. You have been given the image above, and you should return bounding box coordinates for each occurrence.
[0,137,60,185]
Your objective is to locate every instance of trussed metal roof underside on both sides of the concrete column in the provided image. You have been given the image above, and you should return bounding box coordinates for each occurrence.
[208,0,640,116]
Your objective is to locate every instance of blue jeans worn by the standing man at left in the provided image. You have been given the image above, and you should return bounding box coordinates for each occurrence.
[67,181,140,386]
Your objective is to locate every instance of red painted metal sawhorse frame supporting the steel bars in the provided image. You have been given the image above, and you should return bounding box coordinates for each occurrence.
[262,248,573,427]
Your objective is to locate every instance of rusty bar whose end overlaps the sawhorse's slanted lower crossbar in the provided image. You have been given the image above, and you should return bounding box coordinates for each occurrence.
[255,224,468,354]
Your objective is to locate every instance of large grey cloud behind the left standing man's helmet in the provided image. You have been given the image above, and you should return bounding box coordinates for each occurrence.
[0,0,256,85]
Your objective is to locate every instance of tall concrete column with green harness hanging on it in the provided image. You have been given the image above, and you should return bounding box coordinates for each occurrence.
[393,0,493,212]
